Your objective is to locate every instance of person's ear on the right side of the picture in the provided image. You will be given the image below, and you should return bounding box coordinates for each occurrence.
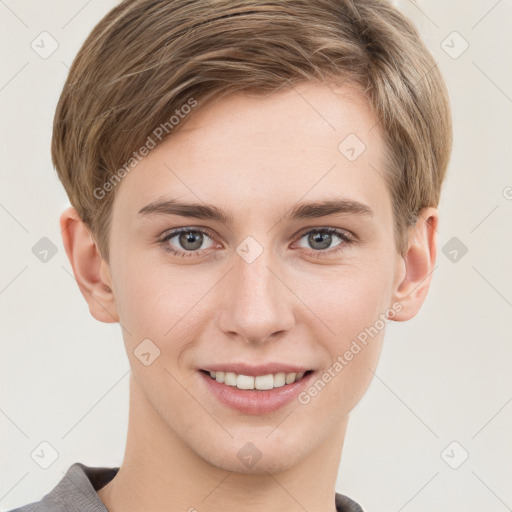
[392,207,439,322]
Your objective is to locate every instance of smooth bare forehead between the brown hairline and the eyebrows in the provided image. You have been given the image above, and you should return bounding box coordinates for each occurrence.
[114,83,389,228]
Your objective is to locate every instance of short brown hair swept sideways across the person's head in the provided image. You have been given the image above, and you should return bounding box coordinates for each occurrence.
[51,0,452,261]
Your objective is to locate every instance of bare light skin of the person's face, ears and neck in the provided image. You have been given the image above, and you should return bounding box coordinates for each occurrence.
[61,83,438,512]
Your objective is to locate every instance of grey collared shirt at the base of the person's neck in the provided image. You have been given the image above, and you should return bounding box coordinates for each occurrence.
[9,462,363,512]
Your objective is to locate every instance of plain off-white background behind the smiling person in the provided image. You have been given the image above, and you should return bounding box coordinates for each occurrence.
[0,0,512,512]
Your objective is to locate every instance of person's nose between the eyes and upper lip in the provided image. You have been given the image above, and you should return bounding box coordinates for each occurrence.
[219,244,295,344]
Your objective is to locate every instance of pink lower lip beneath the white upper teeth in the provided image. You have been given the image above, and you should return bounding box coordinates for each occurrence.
[199,371,314,415]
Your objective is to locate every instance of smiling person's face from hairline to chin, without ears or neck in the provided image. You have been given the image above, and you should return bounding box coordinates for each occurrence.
[109,84,402,472]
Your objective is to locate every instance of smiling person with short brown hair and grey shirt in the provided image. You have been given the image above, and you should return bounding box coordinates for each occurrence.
[9,0,451,512]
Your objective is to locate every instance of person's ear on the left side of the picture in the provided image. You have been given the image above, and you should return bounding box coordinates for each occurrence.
[60,207,119,323]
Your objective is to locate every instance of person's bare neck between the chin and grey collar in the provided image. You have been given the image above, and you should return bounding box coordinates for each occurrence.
[98,376,346,512]
